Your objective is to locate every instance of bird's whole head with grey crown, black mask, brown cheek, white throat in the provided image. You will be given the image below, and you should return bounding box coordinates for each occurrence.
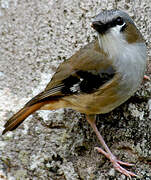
[92,10,144,55]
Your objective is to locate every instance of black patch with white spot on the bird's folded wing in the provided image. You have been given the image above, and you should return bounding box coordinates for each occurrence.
[61,66,115,95]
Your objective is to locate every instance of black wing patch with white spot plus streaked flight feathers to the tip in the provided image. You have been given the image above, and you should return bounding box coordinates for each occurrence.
[25,67,115,107]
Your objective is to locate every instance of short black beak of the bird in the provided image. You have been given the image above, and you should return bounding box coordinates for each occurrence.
[91,21,108,34]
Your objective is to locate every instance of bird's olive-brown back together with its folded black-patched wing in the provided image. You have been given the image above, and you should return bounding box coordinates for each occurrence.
[26,41,115,106]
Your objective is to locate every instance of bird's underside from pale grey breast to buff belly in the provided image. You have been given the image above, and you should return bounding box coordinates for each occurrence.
[65,43,146,114]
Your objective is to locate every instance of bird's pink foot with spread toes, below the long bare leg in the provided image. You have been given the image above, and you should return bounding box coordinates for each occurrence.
[95,147,137,179]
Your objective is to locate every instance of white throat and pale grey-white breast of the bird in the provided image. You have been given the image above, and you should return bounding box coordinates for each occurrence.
[98,26,147,94]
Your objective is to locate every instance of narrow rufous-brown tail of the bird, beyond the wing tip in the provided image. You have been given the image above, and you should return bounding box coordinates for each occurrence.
[2,102,45,134]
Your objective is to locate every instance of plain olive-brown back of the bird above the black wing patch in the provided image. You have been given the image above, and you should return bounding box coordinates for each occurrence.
[45,40,111,90]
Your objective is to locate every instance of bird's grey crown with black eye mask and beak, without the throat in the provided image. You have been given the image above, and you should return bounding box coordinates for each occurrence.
[92,10,135,34]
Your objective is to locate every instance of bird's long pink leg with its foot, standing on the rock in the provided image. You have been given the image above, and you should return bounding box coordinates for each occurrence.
[86,115,137,178]
